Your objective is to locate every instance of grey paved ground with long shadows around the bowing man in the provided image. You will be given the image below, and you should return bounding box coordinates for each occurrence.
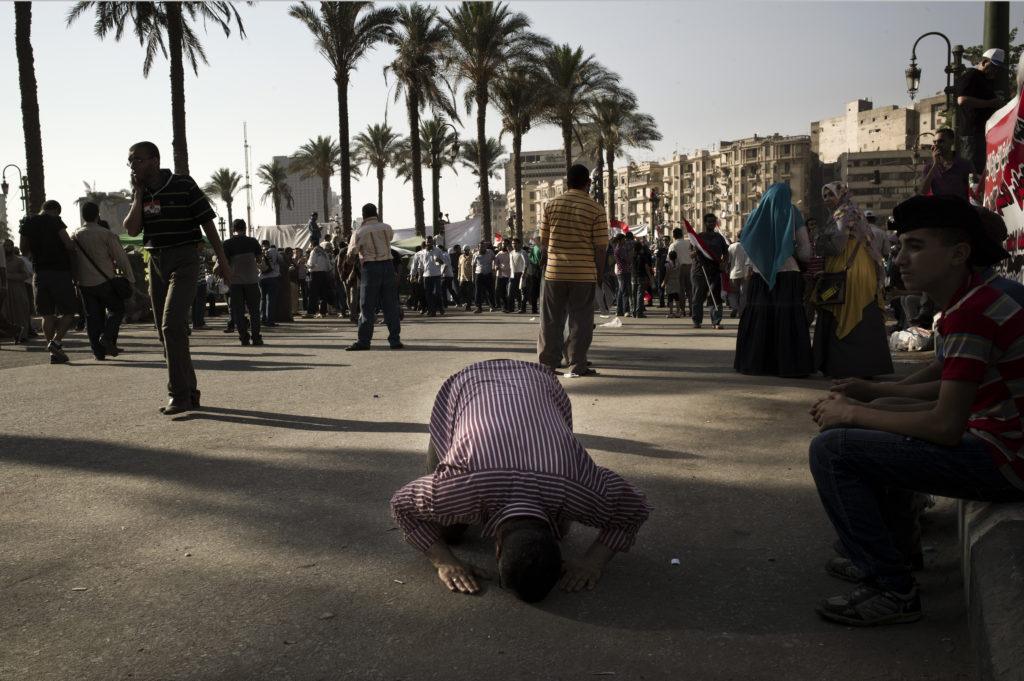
[0,309,973,681]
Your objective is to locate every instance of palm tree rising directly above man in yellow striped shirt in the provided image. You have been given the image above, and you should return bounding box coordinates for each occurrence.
[541,44,618,177]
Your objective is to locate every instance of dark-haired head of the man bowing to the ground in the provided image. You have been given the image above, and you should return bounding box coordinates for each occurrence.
[498,518,562,603]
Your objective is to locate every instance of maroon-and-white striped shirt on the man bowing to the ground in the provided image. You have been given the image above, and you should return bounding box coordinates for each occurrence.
[391,359,651,551]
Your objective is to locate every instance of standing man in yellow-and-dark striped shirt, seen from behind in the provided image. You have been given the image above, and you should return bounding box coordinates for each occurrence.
[537,164,608,377]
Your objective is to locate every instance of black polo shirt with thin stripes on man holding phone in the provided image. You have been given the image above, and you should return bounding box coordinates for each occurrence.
[142,170,217,251]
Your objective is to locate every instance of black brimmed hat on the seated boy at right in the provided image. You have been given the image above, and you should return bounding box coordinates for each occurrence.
[892,195,1010,267]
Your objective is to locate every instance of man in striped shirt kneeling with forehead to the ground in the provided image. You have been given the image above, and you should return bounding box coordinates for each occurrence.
[391,359,651,602]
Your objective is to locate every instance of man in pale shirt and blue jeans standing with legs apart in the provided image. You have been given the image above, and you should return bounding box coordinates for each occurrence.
[345,204,402,350]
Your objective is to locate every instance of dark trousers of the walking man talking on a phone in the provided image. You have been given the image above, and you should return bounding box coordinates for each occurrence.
[150,244,199,403]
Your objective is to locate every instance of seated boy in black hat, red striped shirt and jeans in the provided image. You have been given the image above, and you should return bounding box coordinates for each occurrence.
[810,196,1024,626]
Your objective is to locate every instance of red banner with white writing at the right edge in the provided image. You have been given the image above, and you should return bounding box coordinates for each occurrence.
[983,76,1024,252]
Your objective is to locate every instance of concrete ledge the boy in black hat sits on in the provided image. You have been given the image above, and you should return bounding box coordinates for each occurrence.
[958,501,1024,681]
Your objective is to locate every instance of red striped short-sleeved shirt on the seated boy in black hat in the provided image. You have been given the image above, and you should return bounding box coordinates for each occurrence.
[937,273,1024,488]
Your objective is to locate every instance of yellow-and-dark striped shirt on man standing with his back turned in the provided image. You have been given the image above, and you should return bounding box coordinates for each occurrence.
[541,189,608,283]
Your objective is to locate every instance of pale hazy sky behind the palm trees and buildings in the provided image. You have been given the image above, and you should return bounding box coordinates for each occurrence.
[0,0,1024,228]
